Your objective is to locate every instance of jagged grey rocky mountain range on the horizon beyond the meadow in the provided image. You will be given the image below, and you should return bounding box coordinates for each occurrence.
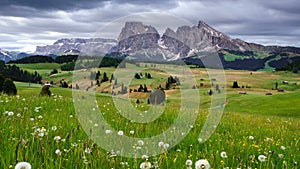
[0,21,300,70]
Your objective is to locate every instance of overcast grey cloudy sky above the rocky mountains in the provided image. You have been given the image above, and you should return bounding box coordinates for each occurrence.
[0,0,300,51]
